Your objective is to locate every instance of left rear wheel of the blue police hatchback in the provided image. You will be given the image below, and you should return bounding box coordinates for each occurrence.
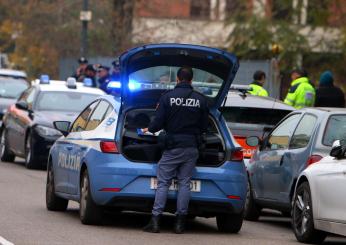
[79,170,103,225]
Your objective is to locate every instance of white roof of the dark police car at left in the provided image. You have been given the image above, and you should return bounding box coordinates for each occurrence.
[34,79,105,95]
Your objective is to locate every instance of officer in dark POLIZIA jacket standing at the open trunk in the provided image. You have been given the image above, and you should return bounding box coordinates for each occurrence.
[142,67,209,234]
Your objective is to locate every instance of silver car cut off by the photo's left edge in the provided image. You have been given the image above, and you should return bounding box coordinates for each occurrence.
[0,69,30,127]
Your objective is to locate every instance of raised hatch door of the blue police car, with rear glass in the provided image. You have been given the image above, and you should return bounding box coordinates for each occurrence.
[120,44,239,109]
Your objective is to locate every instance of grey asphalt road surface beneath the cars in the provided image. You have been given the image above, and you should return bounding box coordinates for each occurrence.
[0,161,346,245]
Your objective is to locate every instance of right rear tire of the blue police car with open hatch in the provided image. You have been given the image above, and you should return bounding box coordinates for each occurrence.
[216,212,244,233]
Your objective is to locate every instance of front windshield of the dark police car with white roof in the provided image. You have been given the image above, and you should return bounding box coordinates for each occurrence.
[36,92,99,112]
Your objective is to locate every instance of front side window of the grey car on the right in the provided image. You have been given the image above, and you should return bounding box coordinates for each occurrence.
[266,114,300,150]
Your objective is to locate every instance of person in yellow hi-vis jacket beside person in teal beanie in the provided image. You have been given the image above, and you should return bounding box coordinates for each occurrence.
[284,69,316,109]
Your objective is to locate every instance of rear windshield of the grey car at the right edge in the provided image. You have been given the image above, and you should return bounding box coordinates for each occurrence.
[322,115,346,146]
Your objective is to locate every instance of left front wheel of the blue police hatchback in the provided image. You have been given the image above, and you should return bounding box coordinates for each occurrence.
[46,164,68,211]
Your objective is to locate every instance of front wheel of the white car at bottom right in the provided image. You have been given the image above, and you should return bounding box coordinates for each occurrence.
[292,182,327,243]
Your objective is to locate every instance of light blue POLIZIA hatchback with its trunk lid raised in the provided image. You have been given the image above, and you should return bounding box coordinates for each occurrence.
[46,44,247,233]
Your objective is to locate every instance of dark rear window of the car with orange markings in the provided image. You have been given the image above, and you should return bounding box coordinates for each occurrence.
[220,107,290,127]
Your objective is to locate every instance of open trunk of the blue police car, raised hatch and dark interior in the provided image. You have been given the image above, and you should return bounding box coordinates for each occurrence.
[116,45,237,166]
